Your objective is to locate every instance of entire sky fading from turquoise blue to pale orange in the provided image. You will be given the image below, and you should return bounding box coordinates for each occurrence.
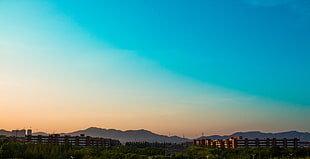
[0,0,310,138]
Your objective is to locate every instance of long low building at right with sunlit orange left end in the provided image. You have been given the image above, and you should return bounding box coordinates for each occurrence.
[194,136,299,148]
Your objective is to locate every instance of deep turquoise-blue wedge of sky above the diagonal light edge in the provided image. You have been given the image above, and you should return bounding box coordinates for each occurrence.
[51,0,310,105]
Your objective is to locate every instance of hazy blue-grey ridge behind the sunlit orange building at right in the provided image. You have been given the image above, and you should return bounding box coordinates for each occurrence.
[198,131,310,141]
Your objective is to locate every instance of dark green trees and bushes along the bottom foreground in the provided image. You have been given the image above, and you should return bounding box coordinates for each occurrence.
[0,140,310,159]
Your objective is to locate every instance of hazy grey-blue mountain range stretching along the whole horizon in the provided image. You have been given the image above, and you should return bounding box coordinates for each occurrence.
[0,127,310,143]
